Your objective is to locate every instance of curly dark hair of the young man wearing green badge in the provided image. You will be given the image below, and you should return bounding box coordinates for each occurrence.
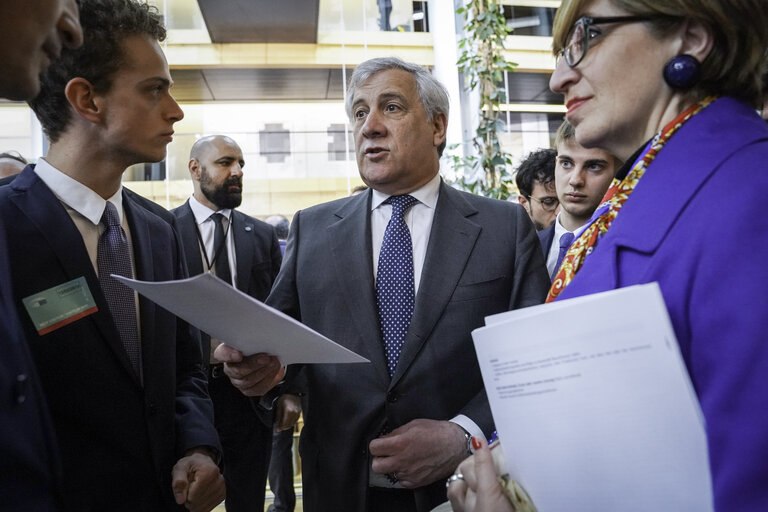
[29,0,166,142]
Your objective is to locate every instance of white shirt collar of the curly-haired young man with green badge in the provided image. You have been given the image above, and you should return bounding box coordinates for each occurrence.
[35,158,123,225]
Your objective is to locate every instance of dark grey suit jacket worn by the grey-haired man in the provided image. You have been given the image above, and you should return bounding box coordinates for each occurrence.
[267,184,549,512]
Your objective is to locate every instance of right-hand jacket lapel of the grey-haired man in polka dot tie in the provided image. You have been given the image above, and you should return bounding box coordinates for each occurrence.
[392,183,480,386]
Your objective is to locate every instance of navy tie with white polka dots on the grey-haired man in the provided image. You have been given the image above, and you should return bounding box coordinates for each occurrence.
[376,195,418,376]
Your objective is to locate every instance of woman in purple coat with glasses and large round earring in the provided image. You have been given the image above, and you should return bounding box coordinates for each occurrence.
[449,0,768,512]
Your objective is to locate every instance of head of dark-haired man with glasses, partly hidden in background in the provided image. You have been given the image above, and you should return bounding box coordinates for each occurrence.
[515,149,559,232]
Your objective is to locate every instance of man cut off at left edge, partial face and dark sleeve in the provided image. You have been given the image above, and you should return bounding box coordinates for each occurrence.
[0,0,83,512]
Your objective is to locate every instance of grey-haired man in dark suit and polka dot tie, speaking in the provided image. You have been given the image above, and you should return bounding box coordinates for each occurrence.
[217,59,549,512]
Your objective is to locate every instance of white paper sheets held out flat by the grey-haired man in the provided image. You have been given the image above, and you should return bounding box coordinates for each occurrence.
[112,273,369,365]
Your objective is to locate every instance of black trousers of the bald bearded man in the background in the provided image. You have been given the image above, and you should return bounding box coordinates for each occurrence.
[208,369,272,512]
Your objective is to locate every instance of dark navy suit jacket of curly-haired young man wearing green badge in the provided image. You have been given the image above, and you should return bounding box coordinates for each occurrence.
[0,166,220,510]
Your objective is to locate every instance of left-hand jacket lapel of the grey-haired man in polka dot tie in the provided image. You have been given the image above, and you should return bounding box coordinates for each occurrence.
[327,191,389,382]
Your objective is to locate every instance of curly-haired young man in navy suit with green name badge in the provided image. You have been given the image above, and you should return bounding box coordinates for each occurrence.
[0,0,224,511]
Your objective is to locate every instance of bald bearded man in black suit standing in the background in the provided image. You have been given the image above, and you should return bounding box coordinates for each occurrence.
[173,135,283,512]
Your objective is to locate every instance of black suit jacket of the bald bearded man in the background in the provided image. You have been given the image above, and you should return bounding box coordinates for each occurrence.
[171,200,283,368]
